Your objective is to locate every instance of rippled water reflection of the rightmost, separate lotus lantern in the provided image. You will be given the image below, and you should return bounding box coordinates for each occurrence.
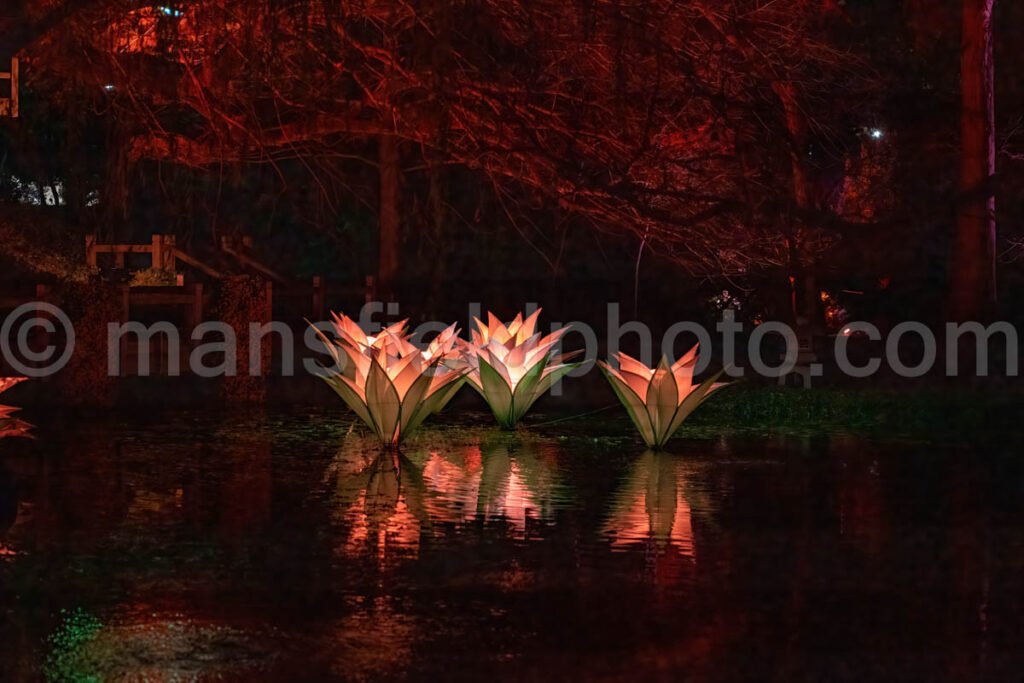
[604,451,696,559]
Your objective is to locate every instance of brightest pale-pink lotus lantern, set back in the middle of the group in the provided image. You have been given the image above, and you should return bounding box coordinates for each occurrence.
[463,309,580,429]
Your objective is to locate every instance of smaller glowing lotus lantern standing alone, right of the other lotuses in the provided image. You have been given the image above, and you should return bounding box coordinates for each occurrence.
[600,346,726,449]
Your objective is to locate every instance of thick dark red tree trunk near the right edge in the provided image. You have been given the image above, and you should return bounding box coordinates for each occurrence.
[949,0,995,321]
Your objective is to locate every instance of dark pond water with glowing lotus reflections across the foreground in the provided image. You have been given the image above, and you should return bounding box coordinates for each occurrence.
[0,414,1024,681]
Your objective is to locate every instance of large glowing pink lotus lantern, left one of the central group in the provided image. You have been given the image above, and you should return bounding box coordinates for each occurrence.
[317,315,465,449]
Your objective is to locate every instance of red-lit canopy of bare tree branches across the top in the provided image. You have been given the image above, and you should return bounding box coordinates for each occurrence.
[9,0,1019,323]
